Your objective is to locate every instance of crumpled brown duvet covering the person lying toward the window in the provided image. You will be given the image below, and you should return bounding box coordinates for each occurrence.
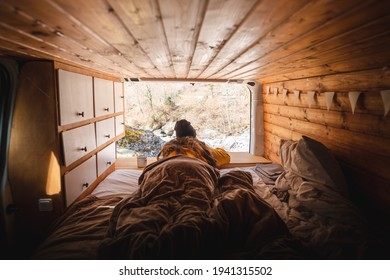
[98,155,302,259]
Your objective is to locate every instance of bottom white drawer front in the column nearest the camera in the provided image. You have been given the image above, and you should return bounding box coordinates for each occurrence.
[65,156,97,206]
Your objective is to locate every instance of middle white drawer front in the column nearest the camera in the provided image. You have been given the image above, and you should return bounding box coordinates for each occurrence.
[62,124,96,166]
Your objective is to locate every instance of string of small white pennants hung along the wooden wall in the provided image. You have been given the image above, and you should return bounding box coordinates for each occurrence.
[266,86,390,116]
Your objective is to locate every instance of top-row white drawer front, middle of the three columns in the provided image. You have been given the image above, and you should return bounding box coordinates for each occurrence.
[93,78,114,117]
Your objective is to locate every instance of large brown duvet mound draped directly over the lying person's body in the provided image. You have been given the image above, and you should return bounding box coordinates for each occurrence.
[100,156,219,259]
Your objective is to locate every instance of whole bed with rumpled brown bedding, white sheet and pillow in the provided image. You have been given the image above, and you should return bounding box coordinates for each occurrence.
[33,137,388,259]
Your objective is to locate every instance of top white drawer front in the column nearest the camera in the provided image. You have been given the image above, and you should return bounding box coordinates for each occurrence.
[58,70,93,125]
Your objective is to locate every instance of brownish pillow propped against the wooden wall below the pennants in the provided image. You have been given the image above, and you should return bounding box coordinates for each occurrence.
[280,136,348,196]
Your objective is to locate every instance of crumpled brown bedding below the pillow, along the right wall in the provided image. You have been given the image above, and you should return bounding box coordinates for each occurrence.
[273,167,389,259]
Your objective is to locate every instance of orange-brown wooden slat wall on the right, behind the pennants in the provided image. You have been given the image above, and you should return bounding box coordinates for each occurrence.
[263,68,390,217]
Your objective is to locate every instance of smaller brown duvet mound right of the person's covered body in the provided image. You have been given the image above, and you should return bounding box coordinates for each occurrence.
[212,171,296,259]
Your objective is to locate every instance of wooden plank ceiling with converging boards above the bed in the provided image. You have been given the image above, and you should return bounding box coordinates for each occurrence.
[0,0,390,82]
